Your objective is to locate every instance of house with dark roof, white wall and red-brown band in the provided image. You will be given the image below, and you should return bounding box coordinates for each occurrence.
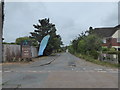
[93,25,120,50]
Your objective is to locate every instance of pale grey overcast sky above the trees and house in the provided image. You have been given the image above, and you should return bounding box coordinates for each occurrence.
[3,2,118,45]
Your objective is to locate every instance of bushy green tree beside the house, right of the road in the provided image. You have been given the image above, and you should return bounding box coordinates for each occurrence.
[69,27,102,58]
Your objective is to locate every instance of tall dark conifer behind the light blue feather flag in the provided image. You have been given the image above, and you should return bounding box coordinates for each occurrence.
[30,18,62,55]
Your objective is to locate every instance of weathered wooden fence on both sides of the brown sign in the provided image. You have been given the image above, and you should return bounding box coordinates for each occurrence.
[3,44,37,62]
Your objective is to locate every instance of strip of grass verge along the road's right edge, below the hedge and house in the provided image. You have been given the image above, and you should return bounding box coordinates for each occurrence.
[74,53,120,68]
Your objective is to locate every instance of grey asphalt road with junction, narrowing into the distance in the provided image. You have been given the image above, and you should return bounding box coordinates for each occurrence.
[2,53,118,88]
